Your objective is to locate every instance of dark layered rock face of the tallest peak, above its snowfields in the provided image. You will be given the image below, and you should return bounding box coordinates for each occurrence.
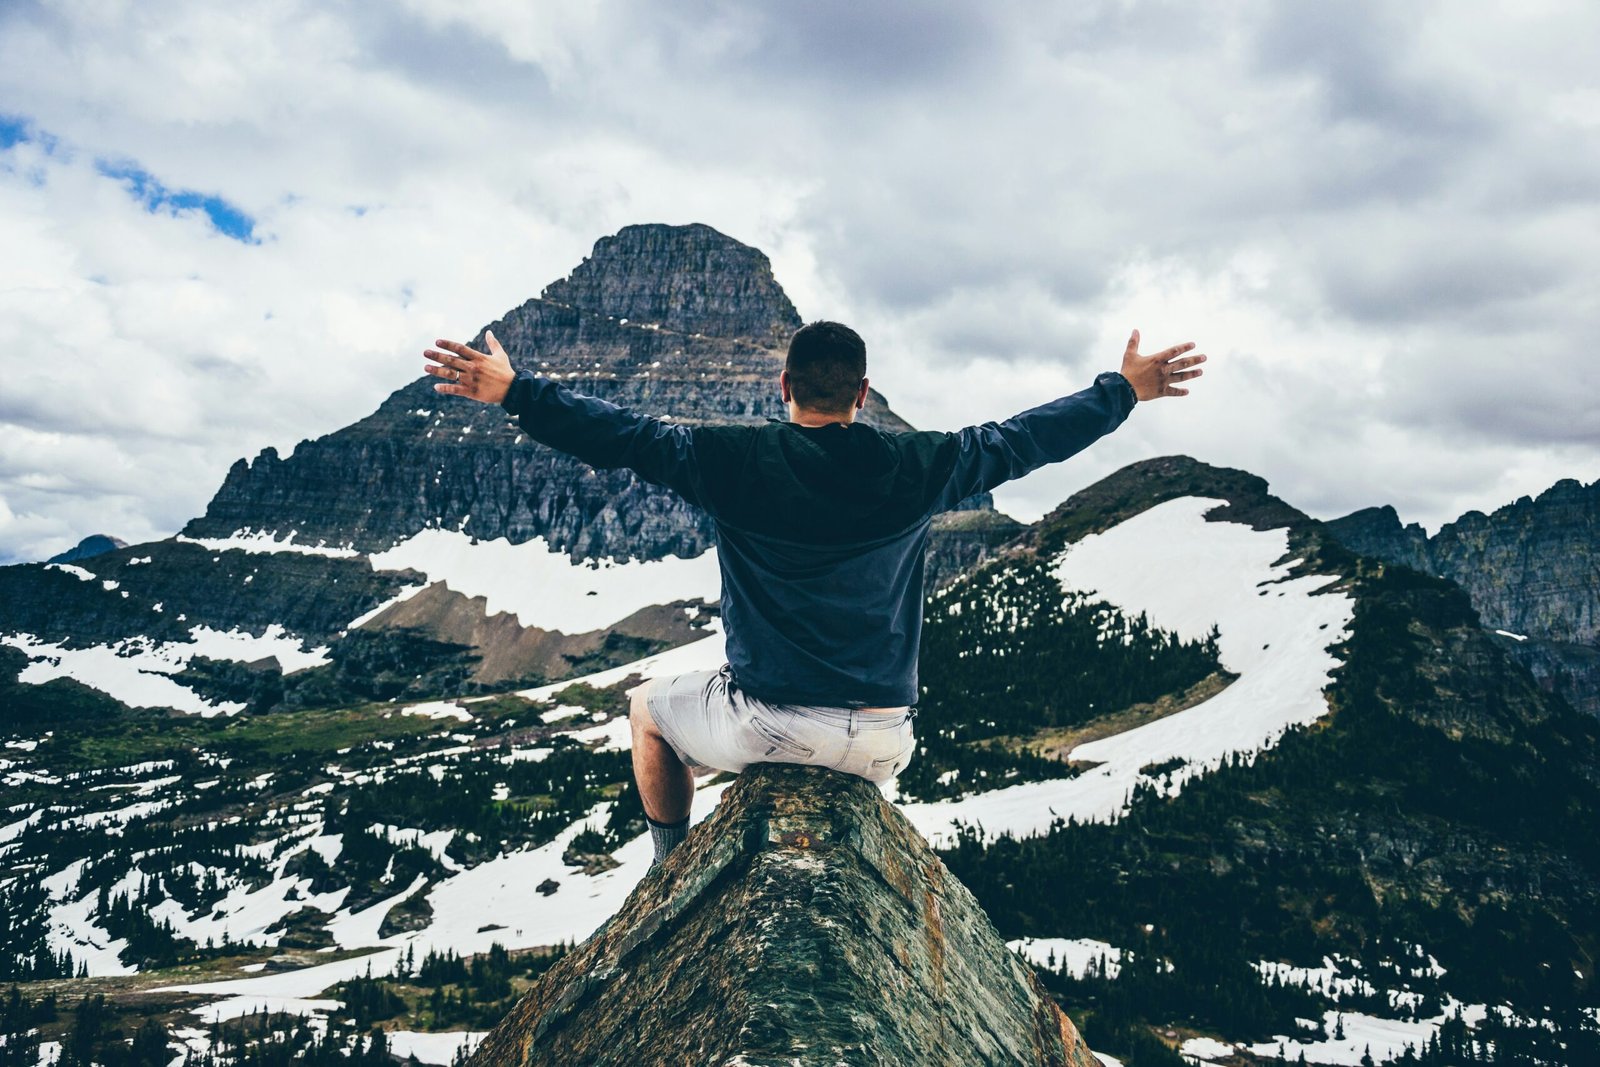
[182,226,989,560]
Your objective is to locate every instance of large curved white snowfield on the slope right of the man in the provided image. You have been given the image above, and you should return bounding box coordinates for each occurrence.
[904,496,1355,846]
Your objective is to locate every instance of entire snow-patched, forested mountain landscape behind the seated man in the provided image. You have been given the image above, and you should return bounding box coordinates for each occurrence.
[0,226,1600,1067]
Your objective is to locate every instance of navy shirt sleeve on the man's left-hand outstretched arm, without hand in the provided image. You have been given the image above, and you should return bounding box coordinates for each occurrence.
[501,370,701,506]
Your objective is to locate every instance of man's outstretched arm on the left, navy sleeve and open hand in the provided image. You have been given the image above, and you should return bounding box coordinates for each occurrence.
[422,333,699,504]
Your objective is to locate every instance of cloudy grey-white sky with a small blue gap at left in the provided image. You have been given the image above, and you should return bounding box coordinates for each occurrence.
[0,0,1600,563]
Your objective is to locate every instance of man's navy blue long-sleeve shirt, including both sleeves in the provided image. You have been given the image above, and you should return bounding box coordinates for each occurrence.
[501,370,1136,707]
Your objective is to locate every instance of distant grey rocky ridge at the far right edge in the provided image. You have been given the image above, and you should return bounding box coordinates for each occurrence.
[1325,478,1600,715]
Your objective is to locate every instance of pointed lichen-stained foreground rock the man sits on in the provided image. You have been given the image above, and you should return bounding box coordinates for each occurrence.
[469,765,1098,1067]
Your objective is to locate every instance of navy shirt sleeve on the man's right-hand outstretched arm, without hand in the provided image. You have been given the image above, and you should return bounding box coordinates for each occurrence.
[934,371,1138,512]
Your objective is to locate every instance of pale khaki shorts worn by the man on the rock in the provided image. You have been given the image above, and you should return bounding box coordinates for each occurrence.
[645,664,917,782]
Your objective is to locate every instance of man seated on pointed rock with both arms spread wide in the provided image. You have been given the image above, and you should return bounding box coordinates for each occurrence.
[422,322,1205,865]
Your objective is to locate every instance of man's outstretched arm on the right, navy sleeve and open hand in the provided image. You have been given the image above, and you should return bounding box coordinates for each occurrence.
[936,330,1205,510]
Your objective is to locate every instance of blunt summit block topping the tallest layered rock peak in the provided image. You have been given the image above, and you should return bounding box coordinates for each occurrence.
[541,222,800,341]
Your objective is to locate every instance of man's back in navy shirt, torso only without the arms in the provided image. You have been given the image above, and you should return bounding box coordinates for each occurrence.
[694,421,958,707]
